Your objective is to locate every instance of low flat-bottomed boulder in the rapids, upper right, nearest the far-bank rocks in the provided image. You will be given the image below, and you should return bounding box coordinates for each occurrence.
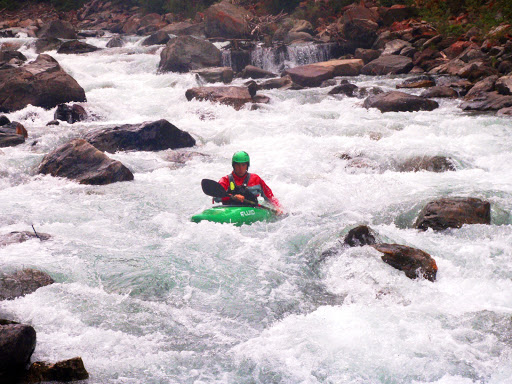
[363,91,439,112]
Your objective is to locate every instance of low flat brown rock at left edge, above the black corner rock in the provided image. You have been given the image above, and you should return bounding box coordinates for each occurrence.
[0,269,55,300]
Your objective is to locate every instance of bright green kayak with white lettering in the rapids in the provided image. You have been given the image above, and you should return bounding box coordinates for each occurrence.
[191,205,275,225]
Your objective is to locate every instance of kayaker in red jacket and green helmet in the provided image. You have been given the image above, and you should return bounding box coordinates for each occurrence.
[215,151,282,214]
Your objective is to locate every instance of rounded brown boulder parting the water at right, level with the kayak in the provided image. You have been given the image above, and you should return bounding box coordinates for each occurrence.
[414,197,491,231]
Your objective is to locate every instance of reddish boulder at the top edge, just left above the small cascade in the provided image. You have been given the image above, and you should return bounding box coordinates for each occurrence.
[204,0,253,39]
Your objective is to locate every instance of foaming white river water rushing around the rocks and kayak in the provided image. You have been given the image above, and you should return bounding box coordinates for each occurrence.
[0,34,512,384]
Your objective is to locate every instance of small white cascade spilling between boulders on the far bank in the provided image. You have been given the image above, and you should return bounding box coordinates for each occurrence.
[222,43,335,73]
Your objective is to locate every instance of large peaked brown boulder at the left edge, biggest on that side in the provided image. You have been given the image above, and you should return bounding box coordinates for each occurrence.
[0,54,86,112]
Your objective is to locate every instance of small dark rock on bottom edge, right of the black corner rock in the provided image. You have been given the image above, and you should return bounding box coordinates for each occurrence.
[23,357,89,384]
